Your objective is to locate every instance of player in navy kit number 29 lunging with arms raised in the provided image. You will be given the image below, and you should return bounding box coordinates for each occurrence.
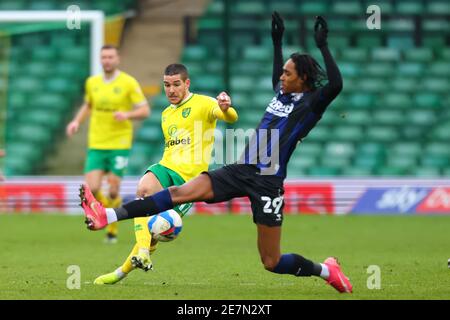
[80,12,352,292]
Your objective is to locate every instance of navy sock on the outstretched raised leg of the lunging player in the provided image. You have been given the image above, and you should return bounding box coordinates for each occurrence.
[114,189,174,220]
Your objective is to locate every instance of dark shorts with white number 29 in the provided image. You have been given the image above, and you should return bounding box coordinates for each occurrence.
[203,164,284,226]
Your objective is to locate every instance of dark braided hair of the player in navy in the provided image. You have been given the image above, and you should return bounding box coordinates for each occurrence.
[290,53,327,90]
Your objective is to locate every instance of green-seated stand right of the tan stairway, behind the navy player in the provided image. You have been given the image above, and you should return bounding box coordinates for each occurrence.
[127,0,450,177]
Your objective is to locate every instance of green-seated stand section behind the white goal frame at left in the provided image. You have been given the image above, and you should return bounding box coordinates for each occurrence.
[0,0,136,176]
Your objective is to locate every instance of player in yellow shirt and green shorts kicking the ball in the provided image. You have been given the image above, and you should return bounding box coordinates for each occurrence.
[94,64,238,284]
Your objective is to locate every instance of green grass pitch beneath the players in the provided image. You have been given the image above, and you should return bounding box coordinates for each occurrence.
[0,215,450,300]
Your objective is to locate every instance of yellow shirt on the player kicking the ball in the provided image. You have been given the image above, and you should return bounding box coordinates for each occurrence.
[159,94,227,181]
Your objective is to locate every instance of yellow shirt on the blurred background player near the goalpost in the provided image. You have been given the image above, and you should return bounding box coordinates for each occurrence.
[85,71,146,150]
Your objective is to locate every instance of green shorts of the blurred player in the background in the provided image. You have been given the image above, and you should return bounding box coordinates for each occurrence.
[84,149,130,177]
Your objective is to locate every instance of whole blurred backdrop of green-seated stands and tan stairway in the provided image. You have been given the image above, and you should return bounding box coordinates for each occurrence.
[0,0,450,177]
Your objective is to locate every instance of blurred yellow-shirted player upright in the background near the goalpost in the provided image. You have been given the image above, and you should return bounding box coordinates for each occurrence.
[66,45,150,243]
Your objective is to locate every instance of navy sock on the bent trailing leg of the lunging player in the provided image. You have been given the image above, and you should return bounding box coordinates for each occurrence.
[272,253,322,277]
